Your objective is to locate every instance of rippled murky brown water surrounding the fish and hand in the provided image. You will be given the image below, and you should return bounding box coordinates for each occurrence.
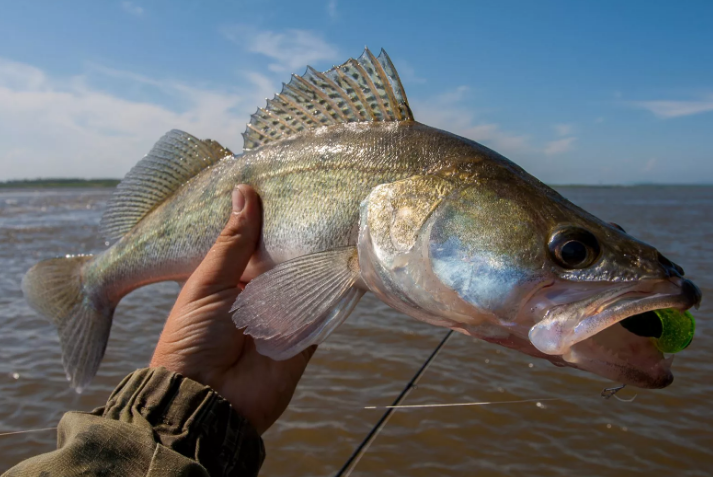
[0,187,713,477]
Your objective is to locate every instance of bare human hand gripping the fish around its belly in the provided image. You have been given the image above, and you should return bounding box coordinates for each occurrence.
[151,185,316,434]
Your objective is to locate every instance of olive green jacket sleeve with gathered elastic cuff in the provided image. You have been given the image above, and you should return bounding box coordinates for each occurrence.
[5,368,265,477]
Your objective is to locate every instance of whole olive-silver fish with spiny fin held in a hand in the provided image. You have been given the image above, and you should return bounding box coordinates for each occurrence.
[22,48,702,390]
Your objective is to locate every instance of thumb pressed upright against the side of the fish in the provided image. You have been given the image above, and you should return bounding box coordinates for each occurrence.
[191,185,262,292]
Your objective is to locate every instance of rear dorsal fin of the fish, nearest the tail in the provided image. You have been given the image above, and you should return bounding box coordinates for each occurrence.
[101,129,232,240]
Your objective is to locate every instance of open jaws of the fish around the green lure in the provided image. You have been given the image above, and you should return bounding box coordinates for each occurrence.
[528,277,701,388]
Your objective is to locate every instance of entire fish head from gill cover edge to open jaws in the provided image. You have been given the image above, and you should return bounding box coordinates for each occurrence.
[359,175,701,388]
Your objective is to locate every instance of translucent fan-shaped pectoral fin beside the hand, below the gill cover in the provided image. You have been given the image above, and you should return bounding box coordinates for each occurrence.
[231,247,364,360]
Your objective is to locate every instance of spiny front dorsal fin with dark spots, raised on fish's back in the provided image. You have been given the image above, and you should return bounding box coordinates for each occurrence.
[243,48,413,151]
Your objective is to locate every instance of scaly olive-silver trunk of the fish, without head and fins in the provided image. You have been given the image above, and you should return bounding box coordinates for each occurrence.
[90,122,462,296]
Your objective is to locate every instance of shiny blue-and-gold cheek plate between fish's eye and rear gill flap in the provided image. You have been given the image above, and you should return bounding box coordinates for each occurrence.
[426,185,545,322]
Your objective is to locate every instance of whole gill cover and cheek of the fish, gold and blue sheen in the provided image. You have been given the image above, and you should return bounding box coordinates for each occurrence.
[359,176,545,331]
